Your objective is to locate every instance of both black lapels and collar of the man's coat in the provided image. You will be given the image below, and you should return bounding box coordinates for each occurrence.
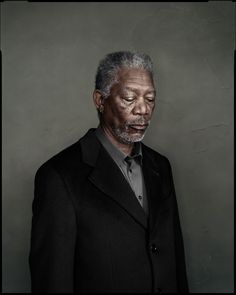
[80,129,160,229]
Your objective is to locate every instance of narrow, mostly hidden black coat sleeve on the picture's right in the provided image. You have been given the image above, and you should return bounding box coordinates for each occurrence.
[168,160,189,293]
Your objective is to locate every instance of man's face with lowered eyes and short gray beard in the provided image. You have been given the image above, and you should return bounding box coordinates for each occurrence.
[102,69,155,144]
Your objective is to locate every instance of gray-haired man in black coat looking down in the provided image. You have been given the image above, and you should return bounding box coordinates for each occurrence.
[30,52,188,293]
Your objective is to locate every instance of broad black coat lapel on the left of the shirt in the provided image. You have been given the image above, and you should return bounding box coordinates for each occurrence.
[81,130,147,228]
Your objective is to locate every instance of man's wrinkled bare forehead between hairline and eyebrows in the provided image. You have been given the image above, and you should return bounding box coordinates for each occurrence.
[115,69,154,90]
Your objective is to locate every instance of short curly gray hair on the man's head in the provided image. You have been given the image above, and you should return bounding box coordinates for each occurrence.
[95,51,153,98]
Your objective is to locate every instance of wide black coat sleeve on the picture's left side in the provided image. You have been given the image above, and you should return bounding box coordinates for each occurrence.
[29,164,76,293]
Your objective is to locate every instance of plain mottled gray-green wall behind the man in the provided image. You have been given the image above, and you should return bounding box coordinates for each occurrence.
[1,1,235,293]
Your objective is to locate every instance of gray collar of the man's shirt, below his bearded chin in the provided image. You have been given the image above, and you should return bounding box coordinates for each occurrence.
[95,125,143,165]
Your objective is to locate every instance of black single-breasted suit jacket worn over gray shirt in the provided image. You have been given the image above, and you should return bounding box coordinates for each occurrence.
[29,129,188,293]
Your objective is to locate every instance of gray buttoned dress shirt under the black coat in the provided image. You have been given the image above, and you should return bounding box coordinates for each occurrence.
[95,126,148,215]
